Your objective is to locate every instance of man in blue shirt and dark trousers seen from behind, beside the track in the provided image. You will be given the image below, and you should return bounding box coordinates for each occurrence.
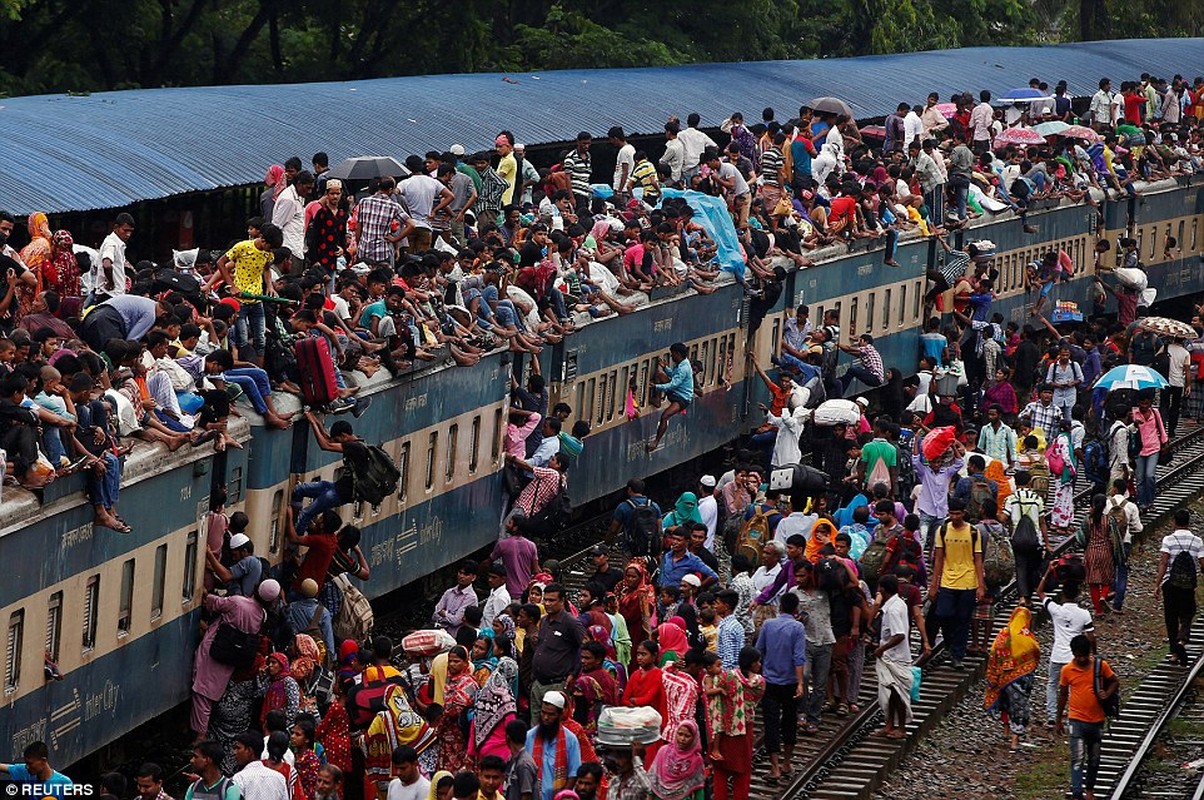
[756,592,807,781]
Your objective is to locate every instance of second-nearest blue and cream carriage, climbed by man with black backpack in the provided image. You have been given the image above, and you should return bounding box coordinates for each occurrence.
[276,353,509,598]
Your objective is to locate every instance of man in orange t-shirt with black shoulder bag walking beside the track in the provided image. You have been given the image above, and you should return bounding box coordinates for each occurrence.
[1054,635,1121,800]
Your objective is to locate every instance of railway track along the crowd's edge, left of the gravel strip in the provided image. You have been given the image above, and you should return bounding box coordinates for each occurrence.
[561,428,1204,800]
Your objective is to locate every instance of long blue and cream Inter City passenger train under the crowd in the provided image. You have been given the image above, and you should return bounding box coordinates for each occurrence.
[0,177,1204,764]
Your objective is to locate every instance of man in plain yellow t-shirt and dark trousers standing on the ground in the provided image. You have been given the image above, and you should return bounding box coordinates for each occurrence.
[928,498,986,670]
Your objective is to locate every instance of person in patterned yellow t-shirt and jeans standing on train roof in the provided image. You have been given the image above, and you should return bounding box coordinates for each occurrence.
[202,222,284,366]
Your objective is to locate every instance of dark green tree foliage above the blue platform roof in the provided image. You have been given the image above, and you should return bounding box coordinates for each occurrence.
[0,0,1184,94]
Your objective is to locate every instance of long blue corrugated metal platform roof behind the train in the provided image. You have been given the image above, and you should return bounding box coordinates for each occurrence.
[0,39,1204,212]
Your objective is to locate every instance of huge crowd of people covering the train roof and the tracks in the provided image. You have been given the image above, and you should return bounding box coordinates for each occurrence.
[0,64,1204,800]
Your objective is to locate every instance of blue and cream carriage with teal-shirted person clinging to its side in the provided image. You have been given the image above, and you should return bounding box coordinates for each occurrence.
[541,276,746,496]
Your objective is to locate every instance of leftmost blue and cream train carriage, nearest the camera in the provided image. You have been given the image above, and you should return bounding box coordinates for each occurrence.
[0,419,250,764]
